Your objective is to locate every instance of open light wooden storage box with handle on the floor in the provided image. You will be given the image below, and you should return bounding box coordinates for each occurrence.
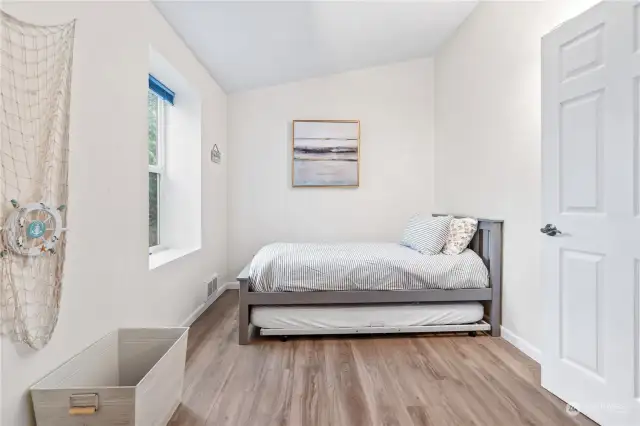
[31,328,189,426]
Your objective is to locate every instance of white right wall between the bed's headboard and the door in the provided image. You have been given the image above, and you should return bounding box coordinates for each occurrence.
[435,0,597,347]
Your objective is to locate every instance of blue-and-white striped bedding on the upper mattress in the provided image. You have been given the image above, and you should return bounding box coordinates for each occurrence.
[249,243,489,292]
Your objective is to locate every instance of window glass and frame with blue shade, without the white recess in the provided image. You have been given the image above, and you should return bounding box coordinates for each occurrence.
[147,75,175,253]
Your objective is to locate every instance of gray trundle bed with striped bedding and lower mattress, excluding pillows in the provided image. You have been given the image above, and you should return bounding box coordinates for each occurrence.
[238,215,503,344]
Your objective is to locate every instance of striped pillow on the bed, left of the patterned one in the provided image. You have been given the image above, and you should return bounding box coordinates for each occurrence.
[400,216,453,254]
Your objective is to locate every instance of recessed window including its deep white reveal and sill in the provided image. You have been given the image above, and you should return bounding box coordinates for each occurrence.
[148,51,202,270]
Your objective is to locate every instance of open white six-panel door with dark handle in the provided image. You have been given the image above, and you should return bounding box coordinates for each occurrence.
[541,1,640,426]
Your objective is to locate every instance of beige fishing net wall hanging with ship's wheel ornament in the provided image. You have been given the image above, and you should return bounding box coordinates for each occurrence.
[0,12,75,349]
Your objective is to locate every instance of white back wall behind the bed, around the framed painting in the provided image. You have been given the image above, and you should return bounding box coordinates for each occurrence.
[228,59,433,273]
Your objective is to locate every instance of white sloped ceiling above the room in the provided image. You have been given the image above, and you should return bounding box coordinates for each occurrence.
[154,0,477,93]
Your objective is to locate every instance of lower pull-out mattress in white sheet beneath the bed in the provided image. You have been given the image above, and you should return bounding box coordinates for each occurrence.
[251,302,484,329]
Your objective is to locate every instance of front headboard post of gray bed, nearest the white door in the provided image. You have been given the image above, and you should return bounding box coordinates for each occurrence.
[488,221,503,337]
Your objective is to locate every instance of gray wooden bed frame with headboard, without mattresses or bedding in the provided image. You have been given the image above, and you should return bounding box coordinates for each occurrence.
[238,214,503,345]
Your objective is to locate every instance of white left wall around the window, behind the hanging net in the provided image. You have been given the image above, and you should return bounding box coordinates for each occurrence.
[2,1,227,426]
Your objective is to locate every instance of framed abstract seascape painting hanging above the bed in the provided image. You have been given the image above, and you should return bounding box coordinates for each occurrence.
[291,120,360,188]
